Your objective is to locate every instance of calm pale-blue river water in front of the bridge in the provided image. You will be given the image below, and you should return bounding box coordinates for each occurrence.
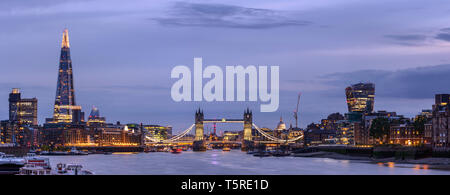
[44,150,450,175]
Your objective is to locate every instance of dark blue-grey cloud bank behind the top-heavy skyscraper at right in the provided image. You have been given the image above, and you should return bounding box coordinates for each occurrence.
[322,64,450,99]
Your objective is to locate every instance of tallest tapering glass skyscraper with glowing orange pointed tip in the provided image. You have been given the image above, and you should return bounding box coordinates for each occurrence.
[53,29,81,123]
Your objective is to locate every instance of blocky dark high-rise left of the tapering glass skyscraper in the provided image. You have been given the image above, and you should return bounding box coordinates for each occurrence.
[9,88,38,126]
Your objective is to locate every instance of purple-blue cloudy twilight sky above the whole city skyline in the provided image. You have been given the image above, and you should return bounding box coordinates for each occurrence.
[0,0,450,132]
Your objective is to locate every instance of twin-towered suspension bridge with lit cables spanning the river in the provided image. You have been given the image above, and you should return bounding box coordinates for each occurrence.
[146,108,303,151]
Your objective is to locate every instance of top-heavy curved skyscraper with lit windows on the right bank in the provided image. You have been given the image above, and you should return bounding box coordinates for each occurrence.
[345,83,375,113]
